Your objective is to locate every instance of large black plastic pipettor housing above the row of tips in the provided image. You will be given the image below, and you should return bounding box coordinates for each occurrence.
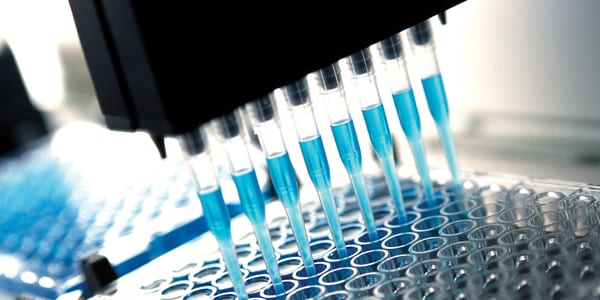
[69,0,464,152]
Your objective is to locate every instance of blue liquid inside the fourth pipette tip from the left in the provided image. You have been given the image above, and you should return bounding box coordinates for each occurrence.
[300,136,348,257]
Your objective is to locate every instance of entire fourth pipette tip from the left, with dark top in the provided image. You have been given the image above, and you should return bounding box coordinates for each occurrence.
[283,78,348,257]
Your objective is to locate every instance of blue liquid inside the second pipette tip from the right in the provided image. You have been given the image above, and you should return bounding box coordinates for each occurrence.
[392,89,435,206]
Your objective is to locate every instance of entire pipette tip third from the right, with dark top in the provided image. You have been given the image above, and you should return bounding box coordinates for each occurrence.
[348,49,406,222]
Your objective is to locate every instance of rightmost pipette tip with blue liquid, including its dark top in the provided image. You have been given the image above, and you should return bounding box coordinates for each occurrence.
[408,20,463,195]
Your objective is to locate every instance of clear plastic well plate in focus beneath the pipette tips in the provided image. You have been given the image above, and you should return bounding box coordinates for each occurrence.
[90,172,600,299]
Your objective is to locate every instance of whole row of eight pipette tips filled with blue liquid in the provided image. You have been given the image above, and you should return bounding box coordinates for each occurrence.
[176,21,462,299]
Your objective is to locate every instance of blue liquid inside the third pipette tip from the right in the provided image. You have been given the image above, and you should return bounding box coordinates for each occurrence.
[362,103,406,222]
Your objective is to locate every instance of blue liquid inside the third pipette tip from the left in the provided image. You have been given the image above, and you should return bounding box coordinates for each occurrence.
[267,152,316,276]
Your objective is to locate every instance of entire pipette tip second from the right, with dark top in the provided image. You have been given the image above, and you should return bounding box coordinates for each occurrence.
[378,34,435,206]
